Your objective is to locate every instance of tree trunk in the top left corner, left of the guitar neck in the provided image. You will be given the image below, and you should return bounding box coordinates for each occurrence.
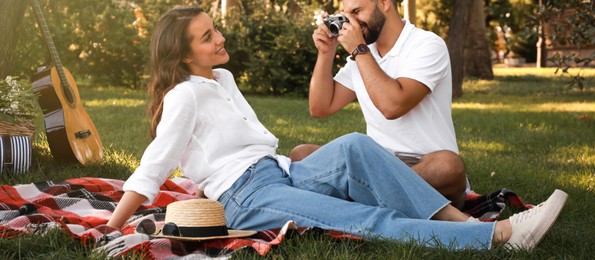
[0,0,28,80]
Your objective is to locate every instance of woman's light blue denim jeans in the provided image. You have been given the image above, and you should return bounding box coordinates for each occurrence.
[219,134,494,249]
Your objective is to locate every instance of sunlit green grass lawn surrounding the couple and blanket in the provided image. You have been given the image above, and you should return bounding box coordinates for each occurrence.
[0,68,595,259]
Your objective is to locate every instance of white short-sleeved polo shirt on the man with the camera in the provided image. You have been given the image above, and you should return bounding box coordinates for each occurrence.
[334,21,459,154]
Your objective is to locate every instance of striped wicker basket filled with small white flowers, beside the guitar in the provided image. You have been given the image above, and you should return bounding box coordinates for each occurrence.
[0,76,41,173]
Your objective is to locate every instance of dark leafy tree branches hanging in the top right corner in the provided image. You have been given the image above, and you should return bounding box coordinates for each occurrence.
[534,0,595,90]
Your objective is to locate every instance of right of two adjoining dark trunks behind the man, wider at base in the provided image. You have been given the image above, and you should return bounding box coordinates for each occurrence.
[463,0,494,79]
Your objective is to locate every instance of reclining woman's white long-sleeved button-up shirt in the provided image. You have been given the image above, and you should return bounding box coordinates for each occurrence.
[123,69,289,202]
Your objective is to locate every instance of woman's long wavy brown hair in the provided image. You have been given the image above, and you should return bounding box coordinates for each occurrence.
[148,7,203,138]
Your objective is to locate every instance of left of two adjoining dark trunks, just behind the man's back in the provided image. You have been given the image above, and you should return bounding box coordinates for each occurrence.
[446,0,473,97]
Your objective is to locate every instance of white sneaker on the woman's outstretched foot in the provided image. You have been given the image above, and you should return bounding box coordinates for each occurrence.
[504,190,568,250]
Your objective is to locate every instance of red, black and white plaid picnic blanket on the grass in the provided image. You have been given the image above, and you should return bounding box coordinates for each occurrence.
[0,178,527,259]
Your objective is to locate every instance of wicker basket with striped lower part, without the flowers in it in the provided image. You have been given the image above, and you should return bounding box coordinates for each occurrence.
[0,121,35,174]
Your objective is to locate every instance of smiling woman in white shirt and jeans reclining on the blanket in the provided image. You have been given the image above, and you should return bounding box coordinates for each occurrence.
[108,7,566,249]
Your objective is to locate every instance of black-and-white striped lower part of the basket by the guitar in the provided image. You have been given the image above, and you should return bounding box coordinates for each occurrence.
[0,136,31,174]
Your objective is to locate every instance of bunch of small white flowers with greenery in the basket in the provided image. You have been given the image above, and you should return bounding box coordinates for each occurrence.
[0,76,41,123]
